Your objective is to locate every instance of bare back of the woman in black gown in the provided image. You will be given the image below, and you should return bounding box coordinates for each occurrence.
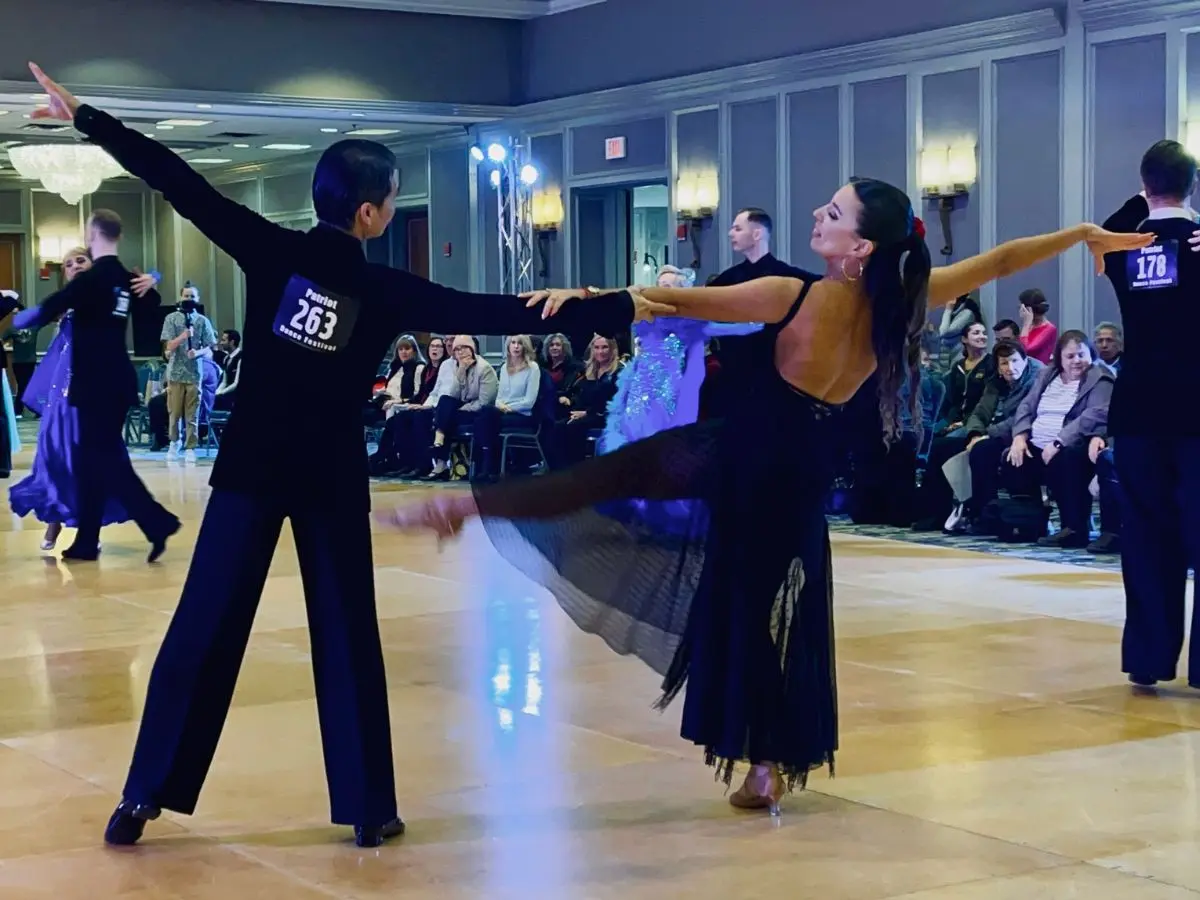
[775,281,876,403]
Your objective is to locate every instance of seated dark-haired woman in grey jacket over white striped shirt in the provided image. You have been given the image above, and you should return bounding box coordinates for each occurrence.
[970,330,1114,547]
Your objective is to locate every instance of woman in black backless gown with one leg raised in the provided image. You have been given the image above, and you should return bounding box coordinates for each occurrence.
[382,180,1150,814]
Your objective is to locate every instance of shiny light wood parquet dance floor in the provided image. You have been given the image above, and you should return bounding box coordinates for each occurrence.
[0,449,1200,900]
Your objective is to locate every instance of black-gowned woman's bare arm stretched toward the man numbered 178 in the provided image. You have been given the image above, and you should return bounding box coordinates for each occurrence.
[929,223,1154,306]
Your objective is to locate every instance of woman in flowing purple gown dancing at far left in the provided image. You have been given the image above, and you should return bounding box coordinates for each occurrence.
[8,247,156,550]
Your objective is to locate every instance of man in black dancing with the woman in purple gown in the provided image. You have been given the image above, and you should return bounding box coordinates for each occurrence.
[13,209,179,563]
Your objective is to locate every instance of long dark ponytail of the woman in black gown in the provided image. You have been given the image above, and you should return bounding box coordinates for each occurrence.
[852,179,932,443]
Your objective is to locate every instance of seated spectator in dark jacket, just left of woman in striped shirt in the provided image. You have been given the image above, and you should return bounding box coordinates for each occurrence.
[913,340,1042,532]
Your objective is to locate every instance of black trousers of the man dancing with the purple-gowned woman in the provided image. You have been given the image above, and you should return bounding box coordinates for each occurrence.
[73,406,179,553]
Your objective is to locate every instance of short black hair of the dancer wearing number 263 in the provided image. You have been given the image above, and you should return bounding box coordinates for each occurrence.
[312,138,396,229]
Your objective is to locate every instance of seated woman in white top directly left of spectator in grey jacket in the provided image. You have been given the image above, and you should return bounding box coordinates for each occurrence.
[371,335,455,478]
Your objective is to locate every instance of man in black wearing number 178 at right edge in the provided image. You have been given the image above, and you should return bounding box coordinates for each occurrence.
[1104,140,1200,688]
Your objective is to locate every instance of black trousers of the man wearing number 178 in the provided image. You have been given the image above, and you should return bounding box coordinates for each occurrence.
[1114,434,1200,684]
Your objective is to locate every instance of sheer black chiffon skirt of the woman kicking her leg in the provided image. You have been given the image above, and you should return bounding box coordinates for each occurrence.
[475,372,840,786]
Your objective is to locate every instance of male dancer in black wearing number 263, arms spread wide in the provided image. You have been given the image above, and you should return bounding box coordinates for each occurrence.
[31,66,667,847]
